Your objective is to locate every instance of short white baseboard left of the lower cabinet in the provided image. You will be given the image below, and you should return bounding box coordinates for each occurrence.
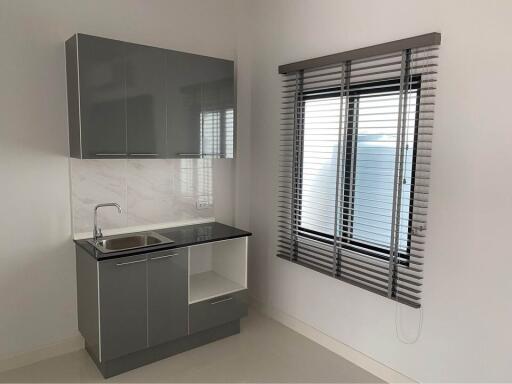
[0,335,84,372]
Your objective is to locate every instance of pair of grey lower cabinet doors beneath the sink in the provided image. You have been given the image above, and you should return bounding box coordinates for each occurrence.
[99,248,188,360]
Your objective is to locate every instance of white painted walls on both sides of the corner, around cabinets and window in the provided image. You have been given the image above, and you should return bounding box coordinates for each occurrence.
[0,0,512,381]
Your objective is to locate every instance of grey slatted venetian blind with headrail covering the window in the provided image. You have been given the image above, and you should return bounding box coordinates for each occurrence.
[277,33,440,307]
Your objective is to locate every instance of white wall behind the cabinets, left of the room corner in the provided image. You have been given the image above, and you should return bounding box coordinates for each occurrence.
[0,0,236,359]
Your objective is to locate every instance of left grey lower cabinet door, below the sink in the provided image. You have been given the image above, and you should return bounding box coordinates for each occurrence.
[99,255,147,361]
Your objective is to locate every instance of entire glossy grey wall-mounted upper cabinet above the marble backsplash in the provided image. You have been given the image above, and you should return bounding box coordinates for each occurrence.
[66,34,236,158]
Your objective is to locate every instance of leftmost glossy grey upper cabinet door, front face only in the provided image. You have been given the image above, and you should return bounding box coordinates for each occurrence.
[77,34,126,158]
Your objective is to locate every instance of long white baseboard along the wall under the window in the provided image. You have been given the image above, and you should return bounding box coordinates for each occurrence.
[251,298,416,383]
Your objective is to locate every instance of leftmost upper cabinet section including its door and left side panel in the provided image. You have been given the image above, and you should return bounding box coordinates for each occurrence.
[66,34,126,158]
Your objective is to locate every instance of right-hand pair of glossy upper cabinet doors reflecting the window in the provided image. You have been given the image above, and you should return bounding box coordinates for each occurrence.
[166,51,234,158]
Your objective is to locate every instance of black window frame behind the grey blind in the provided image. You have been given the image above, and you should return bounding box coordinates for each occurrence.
[295,75,421,267]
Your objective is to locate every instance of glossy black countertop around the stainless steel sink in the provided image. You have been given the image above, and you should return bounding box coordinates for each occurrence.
[74,222,252,260]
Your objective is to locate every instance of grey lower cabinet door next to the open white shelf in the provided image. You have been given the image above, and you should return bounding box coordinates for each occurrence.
[148,248,188,346]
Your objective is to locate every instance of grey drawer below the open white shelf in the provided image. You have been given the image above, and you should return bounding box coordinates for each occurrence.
[189,289,248,333]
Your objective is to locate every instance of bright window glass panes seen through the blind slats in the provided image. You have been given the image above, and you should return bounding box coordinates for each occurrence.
[299,77,421,259]
